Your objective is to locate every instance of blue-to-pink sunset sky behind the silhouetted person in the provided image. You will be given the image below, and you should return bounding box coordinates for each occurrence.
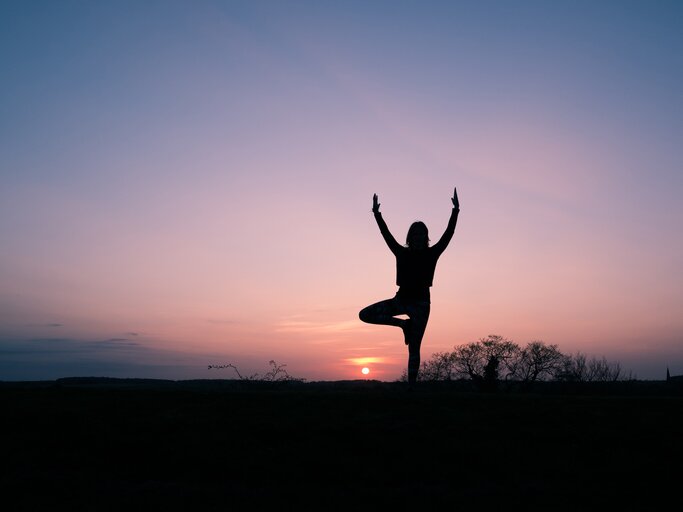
[0,0,683,380]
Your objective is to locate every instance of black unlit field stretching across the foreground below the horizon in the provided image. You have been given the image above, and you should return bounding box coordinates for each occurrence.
[0,379,683,510]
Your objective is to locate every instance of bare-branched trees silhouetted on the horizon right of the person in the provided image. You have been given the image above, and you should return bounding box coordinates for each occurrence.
[400,334,635,389]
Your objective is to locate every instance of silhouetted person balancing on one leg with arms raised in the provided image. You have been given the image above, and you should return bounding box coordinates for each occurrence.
[358,189,460,385]
